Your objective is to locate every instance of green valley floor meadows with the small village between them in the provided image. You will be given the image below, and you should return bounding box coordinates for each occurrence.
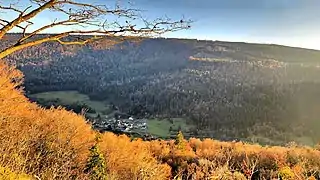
[29,91,192,139]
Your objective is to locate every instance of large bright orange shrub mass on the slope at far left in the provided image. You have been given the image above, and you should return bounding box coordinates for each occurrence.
[0,62,94,179]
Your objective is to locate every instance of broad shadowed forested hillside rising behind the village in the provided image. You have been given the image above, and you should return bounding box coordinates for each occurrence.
[1,34,320,144]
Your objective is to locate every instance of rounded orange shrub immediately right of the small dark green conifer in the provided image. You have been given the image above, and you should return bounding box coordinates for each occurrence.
[100,133,170,180]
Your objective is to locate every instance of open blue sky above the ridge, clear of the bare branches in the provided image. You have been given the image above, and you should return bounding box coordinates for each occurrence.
[0,0,320,50]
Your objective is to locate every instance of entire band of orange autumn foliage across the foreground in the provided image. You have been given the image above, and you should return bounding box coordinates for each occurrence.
[0,59,320,180]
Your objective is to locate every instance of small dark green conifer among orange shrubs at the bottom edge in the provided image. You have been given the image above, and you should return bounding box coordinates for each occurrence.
[85,135,107,180]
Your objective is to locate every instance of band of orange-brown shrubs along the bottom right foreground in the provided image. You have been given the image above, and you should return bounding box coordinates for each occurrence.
[151,134,320,179]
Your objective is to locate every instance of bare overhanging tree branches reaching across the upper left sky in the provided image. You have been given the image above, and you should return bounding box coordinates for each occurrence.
[0,0,190,59]
